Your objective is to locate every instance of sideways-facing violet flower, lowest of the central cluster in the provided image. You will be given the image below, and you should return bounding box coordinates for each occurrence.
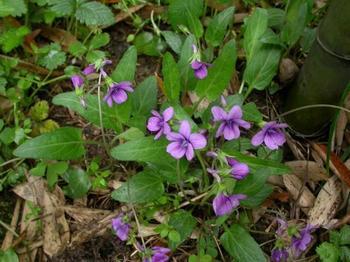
[213,194,247,216]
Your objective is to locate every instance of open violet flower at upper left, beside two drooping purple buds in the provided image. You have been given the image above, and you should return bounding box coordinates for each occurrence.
[103,81,134,107]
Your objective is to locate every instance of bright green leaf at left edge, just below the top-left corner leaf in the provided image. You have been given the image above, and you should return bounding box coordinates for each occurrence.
[0,26,30,53]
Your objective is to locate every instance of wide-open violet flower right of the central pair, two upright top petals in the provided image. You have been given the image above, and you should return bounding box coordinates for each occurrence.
[211,105,250,140]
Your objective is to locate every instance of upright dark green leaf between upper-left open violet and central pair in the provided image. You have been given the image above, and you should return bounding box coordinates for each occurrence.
[131,76,158,116]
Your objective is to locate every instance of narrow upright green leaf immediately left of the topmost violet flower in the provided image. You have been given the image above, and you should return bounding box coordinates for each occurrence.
[178,35,197,90]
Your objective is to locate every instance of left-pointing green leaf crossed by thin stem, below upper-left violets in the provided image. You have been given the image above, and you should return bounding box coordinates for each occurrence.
[52,92,131,130]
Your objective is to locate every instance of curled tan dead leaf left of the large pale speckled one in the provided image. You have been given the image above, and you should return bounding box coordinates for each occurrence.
[283,175,315,214]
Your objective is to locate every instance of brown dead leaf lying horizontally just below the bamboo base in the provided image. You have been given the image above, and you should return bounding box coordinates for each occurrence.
[284,160,328,182]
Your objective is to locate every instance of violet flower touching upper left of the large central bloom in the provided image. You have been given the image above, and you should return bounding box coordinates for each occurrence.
[147,107,174,139]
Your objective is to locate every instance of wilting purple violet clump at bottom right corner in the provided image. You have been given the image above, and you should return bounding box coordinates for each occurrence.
[271,219,315,262]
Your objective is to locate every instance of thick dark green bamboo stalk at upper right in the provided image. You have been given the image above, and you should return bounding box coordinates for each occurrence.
[284,0,350,136]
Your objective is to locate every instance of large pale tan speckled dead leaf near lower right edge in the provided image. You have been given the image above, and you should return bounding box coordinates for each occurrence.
[308,176,342,227]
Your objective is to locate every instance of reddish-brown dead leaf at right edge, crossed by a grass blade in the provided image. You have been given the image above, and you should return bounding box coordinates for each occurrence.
[311,143,350,187]
